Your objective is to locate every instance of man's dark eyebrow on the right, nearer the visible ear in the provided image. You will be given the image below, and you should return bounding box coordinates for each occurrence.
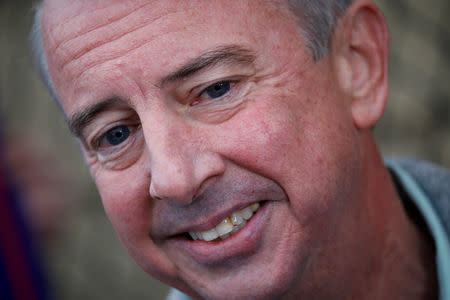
[160,45,256,86]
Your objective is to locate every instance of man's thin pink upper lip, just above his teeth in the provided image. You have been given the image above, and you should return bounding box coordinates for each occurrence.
[156,201,260,238]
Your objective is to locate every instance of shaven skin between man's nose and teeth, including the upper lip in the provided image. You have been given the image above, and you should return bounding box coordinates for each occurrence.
[149,177,287,241]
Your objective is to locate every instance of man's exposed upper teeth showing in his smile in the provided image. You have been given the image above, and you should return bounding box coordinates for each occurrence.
[189,203,260,242]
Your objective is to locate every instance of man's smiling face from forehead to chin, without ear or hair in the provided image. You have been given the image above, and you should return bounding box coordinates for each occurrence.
[43,0,366,299]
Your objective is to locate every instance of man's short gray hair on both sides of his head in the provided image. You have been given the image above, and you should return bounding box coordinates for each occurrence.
[30,0,353,103]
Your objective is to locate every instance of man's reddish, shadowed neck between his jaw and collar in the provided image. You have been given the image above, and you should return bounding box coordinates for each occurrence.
[356,139,438,299]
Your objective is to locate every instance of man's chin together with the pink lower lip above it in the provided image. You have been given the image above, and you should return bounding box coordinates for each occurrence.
[149,201,309,299]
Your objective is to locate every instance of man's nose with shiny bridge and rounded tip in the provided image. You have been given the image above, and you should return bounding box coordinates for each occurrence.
[143,110,224,205]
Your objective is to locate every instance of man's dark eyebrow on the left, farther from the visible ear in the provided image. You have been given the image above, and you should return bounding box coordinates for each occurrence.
[69,98,124,137]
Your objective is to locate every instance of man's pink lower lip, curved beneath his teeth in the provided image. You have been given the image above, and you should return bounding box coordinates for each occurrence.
[172,202,271,264]
